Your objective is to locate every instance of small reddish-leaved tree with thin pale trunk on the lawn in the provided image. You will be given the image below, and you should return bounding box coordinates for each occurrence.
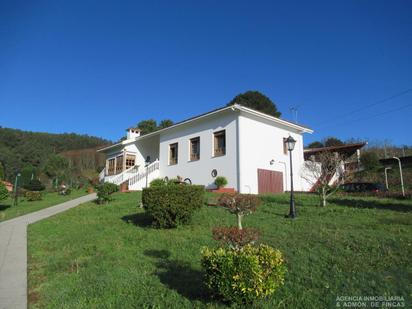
[218,193,260,230]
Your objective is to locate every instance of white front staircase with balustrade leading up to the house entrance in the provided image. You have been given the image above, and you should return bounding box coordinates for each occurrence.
[103,160,160,191]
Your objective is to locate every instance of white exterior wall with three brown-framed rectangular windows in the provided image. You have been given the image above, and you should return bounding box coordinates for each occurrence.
[159,111,238,188]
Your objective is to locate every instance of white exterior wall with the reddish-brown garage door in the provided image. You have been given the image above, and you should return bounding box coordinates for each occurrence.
[238,113,305,194]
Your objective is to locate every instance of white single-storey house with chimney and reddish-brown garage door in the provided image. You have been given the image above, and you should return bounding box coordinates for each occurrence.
[99,105,313,193]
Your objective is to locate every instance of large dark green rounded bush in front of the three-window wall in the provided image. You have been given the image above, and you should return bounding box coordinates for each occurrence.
[142,185,204,228]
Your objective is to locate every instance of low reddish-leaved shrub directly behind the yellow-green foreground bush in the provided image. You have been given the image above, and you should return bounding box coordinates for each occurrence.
[212,226,259,248]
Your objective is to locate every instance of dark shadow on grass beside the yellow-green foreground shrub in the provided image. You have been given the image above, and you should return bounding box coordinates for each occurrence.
[144,250,213,303]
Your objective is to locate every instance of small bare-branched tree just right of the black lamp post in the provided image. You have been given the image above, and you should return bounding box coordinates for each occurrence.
[302,151,344,206]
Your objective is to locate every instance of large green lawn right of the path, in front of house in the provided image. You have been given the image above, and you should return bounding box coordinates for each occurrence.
[28,193,412,308]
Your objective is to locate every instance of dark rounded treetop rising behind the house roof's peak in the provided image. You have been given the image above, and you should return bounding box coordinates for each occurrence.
[227,91,281,117]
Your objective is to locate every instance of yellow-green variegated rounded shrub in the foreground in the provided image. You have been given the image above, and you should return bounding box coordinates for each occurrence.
[202,245,286,304]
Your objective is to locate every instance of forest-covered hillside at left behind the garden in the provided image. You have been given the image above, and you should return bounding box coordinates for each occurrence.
[0,127,111,180]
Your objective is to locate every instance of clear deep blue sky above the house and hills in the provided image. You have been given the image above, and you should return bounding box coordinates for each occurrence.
[0,0,412,145]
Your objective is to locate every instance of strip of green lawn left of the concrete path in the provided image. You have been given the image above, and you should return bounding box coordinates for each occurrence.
[0,190,86,222]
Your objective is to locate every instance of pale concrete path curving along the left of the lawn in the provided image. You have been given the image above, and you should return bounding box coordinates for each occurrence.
[0,193,96,309]
